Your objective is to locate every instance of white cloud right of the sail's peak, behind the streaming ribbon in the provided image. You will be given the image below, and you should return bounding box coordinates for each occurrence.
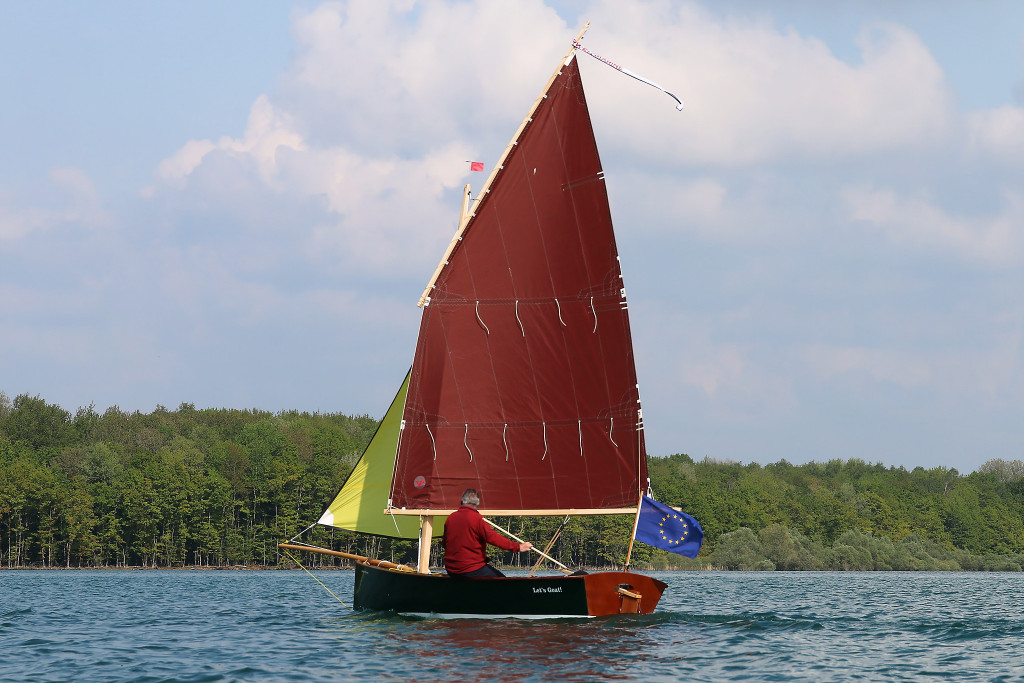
[591,1,954,166]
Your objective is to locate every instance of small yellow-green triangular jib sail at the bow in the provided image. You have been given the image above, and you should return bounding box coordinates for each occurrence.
[319,368,444,539]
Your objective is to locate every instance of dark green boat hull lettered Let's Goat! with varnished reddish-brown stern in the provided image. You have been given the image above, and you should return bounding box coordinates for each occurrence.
[354,563,666,618]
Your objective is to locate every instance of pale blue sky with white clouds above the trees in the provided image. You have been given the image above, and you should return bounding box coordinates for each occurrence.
[0,0,1024,472]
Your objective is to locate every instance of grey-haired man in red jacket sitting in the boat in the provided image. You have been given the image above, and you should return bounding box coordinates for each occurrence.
[441,488,534,577]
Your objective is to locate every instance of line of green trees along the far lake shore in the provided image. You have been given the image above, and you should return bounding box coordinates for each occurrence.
[0,392,1024,570]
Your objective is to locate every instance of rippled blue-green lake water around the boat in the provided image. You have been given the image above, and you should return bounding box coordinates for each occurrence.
[0,570,1024,682]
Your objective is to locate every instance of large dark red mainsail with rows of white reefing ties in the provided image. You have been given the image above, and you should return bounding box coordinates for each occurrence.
[391,57,647,511]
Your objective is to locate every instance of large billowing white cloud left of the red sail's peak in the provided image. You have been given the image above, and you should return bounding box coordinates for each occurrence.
[149,1,577,274]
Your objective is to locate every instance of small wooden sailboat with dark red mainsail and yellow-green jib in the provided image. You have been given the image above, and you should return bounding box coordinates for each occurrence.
[282,26,671,617]
